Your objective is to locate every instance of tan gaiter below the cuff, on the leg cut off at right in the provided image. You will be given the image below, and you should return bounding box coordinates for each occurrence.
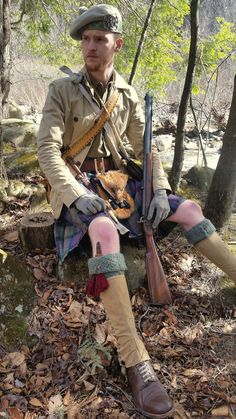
[195,232,236,284]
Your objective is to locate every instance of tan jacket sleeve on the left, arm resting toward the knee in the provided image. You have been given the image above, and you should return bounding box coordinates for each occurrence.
[37,82,85,207]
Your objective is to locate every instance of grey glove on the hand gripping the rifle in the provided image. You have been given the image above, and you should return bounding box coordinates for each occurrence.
[147,189,170,228]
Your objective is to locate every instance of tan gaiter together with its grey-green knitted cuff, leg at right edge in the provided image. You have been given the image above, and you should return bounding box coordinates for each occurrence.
[186,219,236,283]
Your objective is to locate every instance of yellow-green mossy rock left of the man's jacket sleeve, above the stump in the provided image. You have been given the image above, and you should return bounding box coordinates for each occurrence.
[6,148,41,175]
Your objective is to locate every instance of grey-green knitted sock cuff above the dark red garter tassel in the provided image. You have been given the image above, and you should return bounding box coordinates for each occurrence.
[88,253,127,278]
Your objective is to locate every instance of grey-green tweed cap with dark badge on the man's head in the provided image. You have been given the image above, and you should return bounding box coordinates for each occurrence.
[70,4,122,40]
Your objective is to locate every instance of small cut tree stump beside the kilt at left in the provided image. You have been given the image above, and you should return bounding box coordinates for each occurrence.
[19,212,55,251]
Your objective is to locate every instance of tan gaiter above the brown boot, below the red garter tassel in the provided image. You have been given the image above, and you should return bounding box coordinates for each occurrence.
[100,275,150,368]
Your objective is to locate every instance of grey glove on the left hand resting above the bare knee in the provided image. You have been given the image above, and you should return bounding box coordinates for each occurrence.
[74,194,106,215]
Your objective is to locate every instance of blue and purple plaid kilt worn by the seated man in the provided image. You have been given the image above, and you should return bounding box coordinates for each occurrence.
[54,179,184,261]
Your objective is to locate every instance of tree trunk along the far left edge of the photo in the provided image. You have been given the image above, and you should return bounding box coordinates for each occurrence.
[0,0,11,178]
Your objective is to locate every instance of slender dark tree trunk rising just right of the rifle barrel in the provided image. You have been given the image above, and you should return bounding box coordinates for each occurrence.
[169,0,199,191]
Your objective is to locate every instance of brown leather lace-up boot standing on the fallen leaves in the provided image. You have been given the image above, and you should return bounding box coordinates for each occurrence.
[127,361,173,418]
